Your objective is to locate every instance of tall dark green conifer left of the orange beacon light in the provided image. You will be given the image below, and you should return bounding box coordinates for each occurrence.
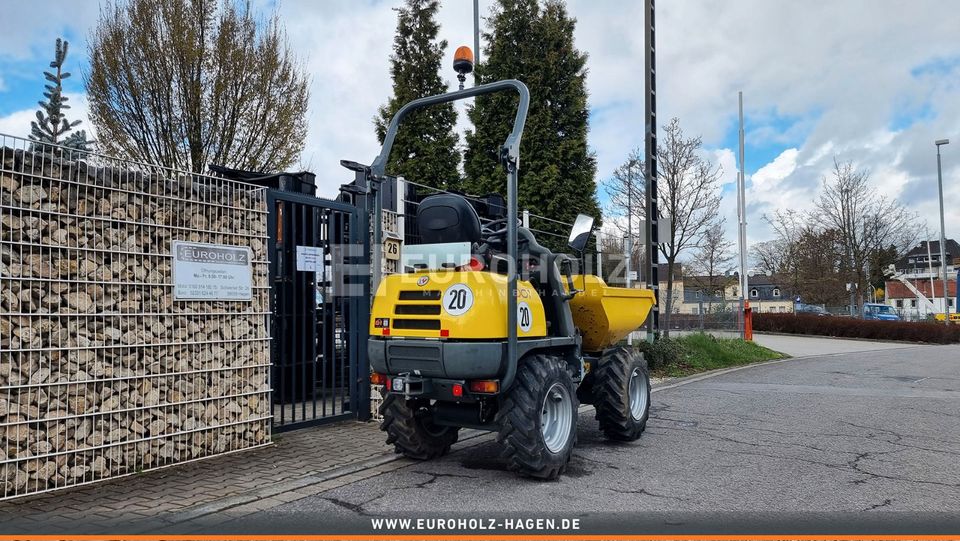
[374,0,460,189]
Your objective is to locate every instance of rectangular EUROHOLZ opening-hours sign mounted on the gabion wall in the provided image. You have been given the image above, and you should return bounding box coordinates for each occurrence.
[171,240,253,301]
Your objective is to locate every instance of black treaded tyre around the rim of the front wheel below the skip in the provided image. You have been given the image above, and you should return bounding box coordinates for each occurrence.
[591,348,651,441]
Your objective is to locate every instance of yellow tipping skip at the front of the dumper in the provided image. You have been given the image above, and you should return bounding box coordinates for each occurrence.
[570,274,654,351]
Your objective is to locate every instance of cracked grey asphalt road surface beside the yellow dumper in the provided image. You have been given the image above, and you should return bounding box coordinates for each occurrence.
[221,346,960,532]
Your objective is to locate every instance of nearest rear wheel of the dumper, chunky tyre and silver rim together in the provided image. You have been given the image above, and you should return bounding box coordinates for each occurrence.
[497,355,578,479]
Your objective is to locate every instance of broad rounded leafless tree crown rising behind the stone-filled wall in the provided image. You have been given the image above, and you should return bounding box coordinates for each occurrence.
[86,0,308,172]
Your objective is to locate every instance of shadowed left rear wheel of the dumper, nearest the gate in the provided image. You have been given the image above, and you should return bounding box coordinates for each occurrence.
[380,394,460,460]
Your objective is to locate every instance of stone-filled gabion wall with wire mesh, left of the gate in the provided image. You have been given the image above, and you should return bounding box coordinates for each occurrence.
[0,135,271,498]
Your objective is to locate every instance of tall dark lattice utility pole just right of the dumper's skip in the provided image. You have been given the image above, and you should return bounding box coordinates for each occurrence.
[643,0,660,342]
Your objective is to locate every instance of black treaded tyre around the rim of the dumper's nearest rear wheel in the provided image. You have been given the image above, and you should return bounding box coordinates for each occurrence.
[496,354,579,480]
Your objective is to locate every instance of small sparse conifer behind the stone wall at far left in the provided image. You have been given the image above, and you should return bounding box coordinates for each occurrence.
[30,38,88,150]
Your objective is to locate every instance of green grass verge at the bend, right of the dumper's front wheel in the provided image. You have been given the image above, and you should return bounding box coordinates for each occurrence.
[641,334,788,377]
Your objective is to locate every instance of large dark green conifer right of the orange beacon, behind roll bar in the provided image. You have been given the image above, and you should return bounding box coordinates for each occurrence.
[464,0,600,243]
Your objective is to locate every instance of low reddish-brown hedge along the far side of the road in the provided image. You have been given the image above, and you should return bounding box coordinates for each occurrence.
[753,314,960,344]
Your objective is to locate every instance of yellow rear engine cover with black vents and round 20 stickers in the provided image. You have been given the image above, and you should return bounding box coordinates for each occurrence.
[370,271,547,340]
